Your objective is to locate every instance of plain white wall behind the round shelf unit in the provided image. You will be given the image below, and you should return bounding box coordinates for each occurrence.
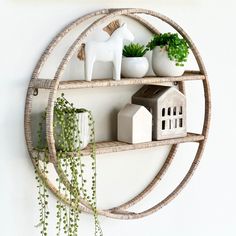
[0,0,236,236]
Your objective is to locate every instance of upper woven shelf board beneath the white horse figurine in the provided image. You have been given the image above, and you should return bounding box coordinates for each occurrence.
[30,71,205,89]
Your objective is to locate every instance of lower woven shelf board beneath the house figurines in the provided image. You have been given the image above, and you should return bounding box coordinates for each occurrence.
[33,133,204,160]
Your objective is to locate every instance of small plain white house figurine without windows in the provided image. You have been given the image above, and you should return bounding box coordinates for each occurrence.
[117,104,152,144]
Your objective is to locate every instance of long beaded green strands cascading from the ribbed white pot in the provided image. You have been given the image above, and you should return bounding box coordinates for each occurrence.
[36,94,103,236]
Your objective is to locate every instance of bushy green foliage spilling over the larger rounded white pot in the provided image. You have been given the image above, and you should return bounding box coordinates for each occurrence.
[147,33,189,66]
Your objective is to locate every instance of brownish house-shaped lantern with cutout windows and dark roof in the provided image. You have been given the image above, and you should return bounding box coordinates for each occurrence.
[132,85,187,140]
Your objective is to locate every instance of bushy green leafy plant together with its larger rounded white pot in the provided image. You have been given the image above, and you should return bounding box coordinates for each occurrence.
[147,33,189,76]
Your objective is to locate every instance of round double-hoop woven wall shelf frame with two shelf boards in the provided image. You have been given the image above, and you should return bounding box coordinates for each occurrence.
[24,9,211,219]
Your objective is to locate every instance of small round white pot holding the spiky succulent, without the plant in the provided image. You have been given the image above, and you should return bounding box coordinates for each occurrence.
[121,57,149,78]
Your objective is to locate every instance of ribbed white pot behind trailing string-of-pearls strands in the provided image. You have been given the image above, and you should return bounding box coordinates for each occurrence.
[54,112,90,151]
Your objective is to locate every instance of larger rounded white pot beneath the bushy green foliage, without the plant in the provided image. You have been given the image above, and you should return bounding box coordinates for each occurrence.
[152,46,185,76]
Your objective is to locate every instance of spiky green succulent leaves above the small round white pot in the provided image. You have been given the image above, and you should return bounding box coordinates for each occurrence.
[123,43,148,57]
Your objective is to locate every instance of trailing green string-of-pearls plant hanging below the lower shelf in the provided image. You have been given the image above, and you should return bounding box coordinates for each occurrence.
[35,93,103,236]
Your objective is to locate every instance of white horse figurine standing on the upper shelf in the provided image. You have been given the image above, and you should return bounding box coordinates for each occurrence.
[78,23,134,81]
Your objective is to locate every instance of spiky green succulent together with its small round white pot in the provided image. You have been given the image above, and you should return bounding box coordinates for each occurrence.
[121,43,149,78]
